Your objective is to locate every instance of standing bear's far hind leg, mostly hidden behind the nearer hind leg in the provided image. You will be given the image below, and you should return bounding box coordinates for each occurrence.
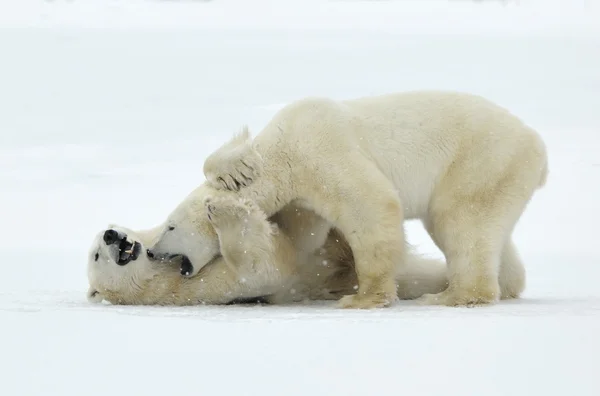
[499,239,526,300]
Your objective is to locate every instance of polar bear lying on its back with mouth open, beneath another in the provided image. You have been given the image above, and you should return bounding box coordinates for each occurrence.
[88,197,448,305]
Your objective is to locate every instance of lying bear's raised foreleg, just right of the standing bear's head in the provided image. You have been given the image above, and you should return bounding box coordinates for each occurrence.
[205,196,296,288]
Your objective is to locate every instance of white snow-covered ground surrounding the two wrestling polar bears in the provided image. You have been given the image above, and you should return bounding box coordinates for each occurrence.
[0,0,600,396]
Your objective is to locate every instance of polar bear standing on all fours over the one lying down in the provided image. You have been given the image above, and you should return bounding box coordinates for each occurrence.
[146,91,548,308]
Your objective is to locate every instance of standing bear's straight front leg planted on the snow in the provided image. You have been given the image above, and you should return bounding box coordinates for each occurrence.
[298,155,405,309]
